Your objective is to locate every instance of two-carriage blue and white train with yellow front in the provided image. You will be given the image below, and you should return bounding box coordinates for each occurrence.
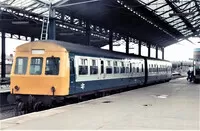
[7,40,172,110]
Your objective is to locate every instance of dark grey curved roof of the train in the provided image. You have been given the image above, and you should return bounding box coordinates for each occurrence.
[27,40,169,62]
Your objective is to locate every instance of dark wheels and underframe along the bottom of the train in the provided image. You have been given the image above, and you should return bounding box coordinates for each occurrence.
[7,85,142,114]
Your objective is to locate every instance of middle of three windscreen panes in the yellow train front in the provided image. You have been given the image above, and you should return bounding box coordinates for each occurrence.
[30,57,43,75]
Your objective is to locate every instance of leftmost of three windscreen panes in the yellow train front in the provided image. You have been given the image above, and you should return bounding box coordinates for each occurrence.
[15,57,28,74]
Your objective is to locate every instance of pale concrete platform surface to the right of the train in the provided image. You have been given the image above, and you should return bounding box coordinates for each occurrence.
[0,78,200,130]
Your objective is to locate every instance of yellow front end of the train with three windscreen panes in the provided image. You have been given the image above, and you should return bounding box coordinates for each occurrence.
[10,42,69,96]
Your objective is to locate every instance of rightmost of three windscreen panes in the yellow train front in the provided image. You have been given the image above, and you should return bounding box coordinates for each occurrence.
[45,57,60,75]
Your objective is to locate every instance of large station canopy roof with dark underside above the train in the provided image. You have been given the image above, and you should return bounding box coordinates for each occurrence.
[0,0,200,47]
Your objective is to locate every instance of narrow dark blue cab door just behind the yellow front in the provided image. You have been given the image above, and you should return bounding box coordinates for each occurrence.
[70,57,76,93]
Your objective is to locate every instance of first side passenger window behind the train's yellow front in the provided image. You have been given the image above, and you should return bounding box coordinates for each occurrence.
[79,59,88,75]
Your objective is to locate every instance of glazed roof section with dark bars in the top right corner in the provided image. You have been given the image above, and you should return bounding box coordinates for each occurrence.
[138,0,200,37]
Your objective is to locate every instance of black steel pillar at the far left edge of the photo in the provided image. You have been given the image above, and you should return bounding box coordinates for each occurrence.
[1,32,6,78]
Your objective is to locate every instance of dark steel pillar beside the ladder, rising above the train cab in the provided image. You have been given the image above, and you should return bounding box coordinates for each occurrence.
[48,9,56,40]
